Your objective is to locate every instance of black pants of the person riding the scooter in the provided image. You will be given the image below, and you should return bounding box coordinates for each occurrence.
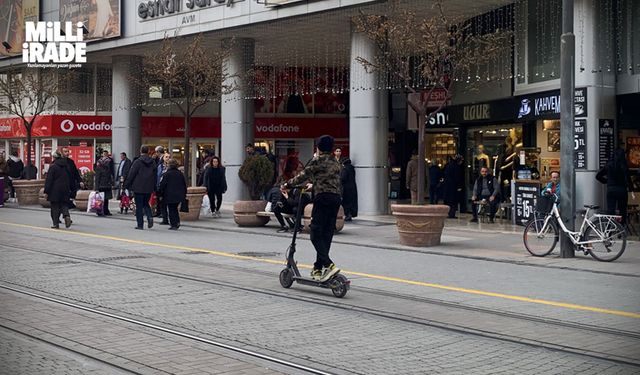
[311,193,340,269]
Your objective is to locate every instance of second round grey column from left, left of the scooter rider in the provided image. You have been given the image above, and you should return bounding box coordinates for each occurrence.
[220,39,255,201]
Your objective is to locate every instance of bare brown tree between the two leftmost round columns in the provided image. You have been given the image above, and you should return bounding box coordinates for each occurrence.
[134,35,233,183]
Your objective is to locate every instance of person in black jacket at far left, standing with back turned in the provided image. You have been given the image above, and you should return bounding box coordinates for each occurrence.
[44,150,71,229]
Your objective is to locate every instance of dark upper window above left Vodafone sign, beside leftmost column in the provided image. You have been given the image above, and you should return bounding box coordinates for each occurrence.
[58,66,94,112]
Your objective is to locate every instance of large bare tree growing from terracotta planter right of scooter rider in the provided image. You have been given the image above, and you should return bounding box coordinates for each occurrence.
[353,0,512,204]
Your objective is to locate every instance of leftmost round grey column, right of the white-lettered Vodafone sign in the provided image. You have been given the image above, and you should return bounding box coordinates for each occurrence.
[111,56,142,164]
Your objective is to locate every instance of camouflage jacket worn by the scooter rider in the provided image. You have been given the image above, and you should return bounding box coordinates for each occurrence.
[287,152,342,195]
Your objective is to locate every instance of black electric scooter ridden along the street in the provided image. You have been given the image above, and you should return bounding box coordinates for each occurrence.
[280,189,351,298]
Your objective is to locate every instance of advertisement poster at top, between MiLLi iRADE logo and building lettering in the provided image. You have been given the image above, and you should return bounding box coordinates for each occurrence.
[59,0,120,41]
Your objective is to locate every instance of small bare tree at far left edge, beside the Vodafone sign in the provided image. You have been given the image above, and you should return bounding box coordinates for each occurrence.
[0,69,59,180]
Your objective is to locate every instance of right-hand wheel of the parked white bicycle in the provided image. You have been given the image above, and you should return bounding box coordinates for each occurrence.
[582,216,627,262]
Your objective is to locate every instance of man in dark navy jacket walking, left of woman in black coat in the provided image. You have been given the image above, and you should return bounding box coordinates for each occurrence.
[124,146,156,229]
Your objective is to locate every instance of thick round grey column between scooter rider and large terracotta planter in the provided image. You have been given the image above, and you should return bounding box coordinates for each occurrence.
[349,27,389,214]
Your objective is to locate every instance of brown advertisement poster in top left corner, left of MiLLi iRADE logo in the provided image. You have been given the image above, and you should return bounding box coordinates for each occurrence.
[0,0,40,58]
